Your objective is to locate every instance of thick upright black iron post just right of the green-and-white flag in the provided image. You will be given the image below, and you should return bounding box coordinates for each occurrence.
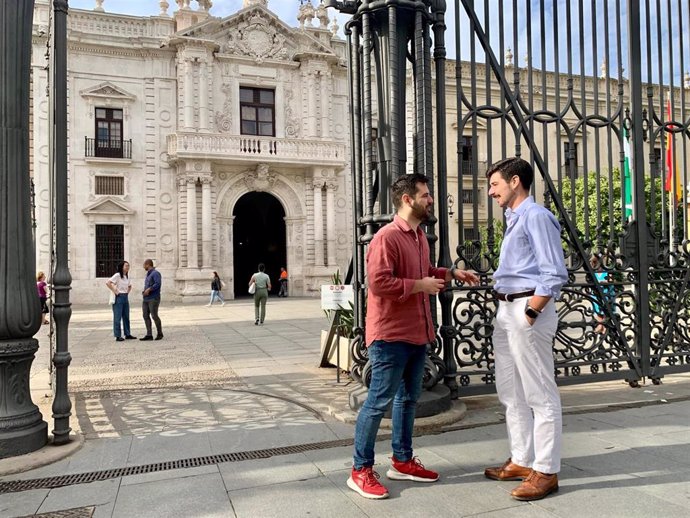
[621,0,651,382]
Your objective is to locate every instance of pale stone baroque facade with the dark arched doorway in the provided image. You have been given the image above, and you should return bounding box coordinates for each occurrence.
[31,0,352,302]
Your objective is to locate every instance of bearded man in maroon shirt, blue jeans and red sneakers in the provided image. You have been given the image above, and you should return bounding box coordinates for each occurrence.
[347,174,479,499]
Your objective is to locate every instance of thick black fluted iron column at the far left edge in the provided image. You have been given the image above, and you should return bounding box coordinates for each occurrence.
[0,0,48,458]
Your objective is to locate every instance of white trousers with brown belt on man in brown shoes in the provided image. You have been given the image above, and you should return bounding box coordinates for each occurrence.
[493,298,562,473]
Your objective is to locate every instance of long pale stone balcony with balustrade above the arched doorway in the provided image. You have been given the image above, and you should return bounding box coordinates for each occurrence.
[168,132,346,167]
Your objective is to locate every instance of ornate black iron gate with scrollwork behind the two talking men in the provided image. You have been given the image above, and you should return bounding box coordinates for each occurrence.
[329,0,690,402]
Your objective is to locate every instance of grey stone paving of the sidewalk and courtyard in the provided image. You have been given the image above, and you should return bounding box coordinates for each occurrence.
[0,298,690,518]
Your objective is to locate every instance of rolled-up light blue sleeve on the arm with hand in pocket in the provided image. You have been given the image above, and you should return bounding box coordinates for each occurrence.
[526,211,568,299]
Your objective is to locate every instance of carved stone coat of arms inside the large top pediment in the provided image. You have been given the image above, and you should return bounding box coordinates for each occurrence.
[222,14,290,63]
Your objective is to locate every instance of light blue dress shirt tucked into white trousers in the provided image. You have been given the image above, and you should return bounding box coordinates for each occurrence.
[494,196,568,299]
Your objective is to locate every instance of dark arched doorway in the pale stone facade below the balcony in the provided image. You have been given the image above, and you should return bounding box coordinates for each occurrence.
[232,192,287,297]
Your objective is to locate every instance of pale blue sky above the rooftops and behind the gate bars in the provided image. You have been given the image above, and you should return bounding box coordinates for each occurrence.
[69,0,690,86]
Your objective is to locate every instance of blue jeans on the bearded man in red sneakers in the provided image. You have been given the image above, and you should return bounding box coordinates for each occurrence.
[354,340,426,469]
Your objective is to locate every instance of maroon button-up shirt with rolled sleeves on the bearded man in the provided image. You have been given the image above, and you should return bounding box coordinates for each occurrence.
[365,215,447,345]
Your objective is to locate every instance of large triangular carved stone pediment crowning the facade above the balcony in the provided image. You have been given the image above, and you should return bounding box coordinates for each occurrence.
[177,5,337,63]
